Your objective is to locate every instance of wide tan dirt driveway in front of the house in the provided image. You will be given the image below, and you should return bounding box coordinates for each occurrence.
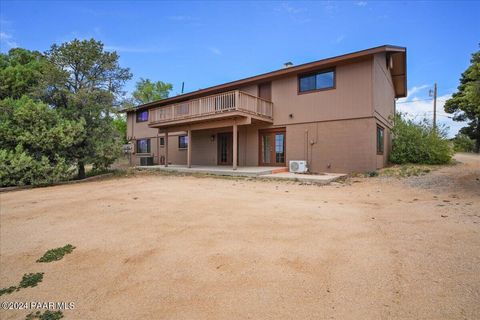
[0,155,480,319]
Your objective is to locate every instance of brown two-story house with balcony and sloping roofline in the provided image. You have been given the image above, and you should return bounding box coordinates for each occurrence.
[127,45,407,172]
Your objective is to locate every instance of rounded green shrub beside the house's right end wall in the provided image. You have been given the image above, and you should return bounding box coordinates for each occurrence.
[390,114,453,164]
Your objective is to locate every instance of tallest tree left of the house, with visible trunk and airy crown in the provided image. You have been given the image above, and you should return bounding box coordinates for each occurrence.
[43,39,132,179]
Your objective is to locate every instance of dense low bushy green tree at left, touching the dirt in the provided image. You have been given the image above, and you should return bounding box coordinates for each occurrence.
[0,96,85,186]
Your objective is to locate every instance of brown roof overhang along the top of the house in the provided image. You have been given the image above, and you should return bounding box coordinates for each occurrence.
[121,45,407,112]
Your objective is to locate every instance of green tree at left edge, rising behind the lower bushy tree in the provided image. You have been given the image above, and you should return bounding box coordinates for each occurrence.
[0,48,47,99]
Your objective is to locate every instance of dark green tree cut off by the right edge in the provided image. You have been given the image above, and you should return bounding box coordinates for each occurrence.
[445,47,480,153]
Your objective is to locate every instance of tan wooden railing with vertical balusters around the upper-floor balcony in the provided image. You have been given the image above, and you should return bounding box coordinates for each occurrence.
[149,90,273,123]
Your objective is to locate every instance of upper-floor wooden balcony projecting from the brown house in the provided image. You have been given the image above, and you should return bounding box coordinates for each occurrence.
[149,90,273,128]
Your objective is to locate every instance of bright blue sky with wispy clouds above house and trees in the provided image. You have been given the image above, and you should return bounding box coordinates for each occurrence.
[0,0,480,135]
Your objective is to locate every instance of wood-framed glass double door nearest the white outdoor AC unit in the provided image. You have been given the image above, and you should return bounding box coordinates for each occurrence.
[258,129,285,166]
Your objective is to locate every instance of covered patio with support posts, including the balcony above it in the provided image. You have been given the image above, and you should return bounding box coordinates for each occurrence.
[149,90,273,173]
